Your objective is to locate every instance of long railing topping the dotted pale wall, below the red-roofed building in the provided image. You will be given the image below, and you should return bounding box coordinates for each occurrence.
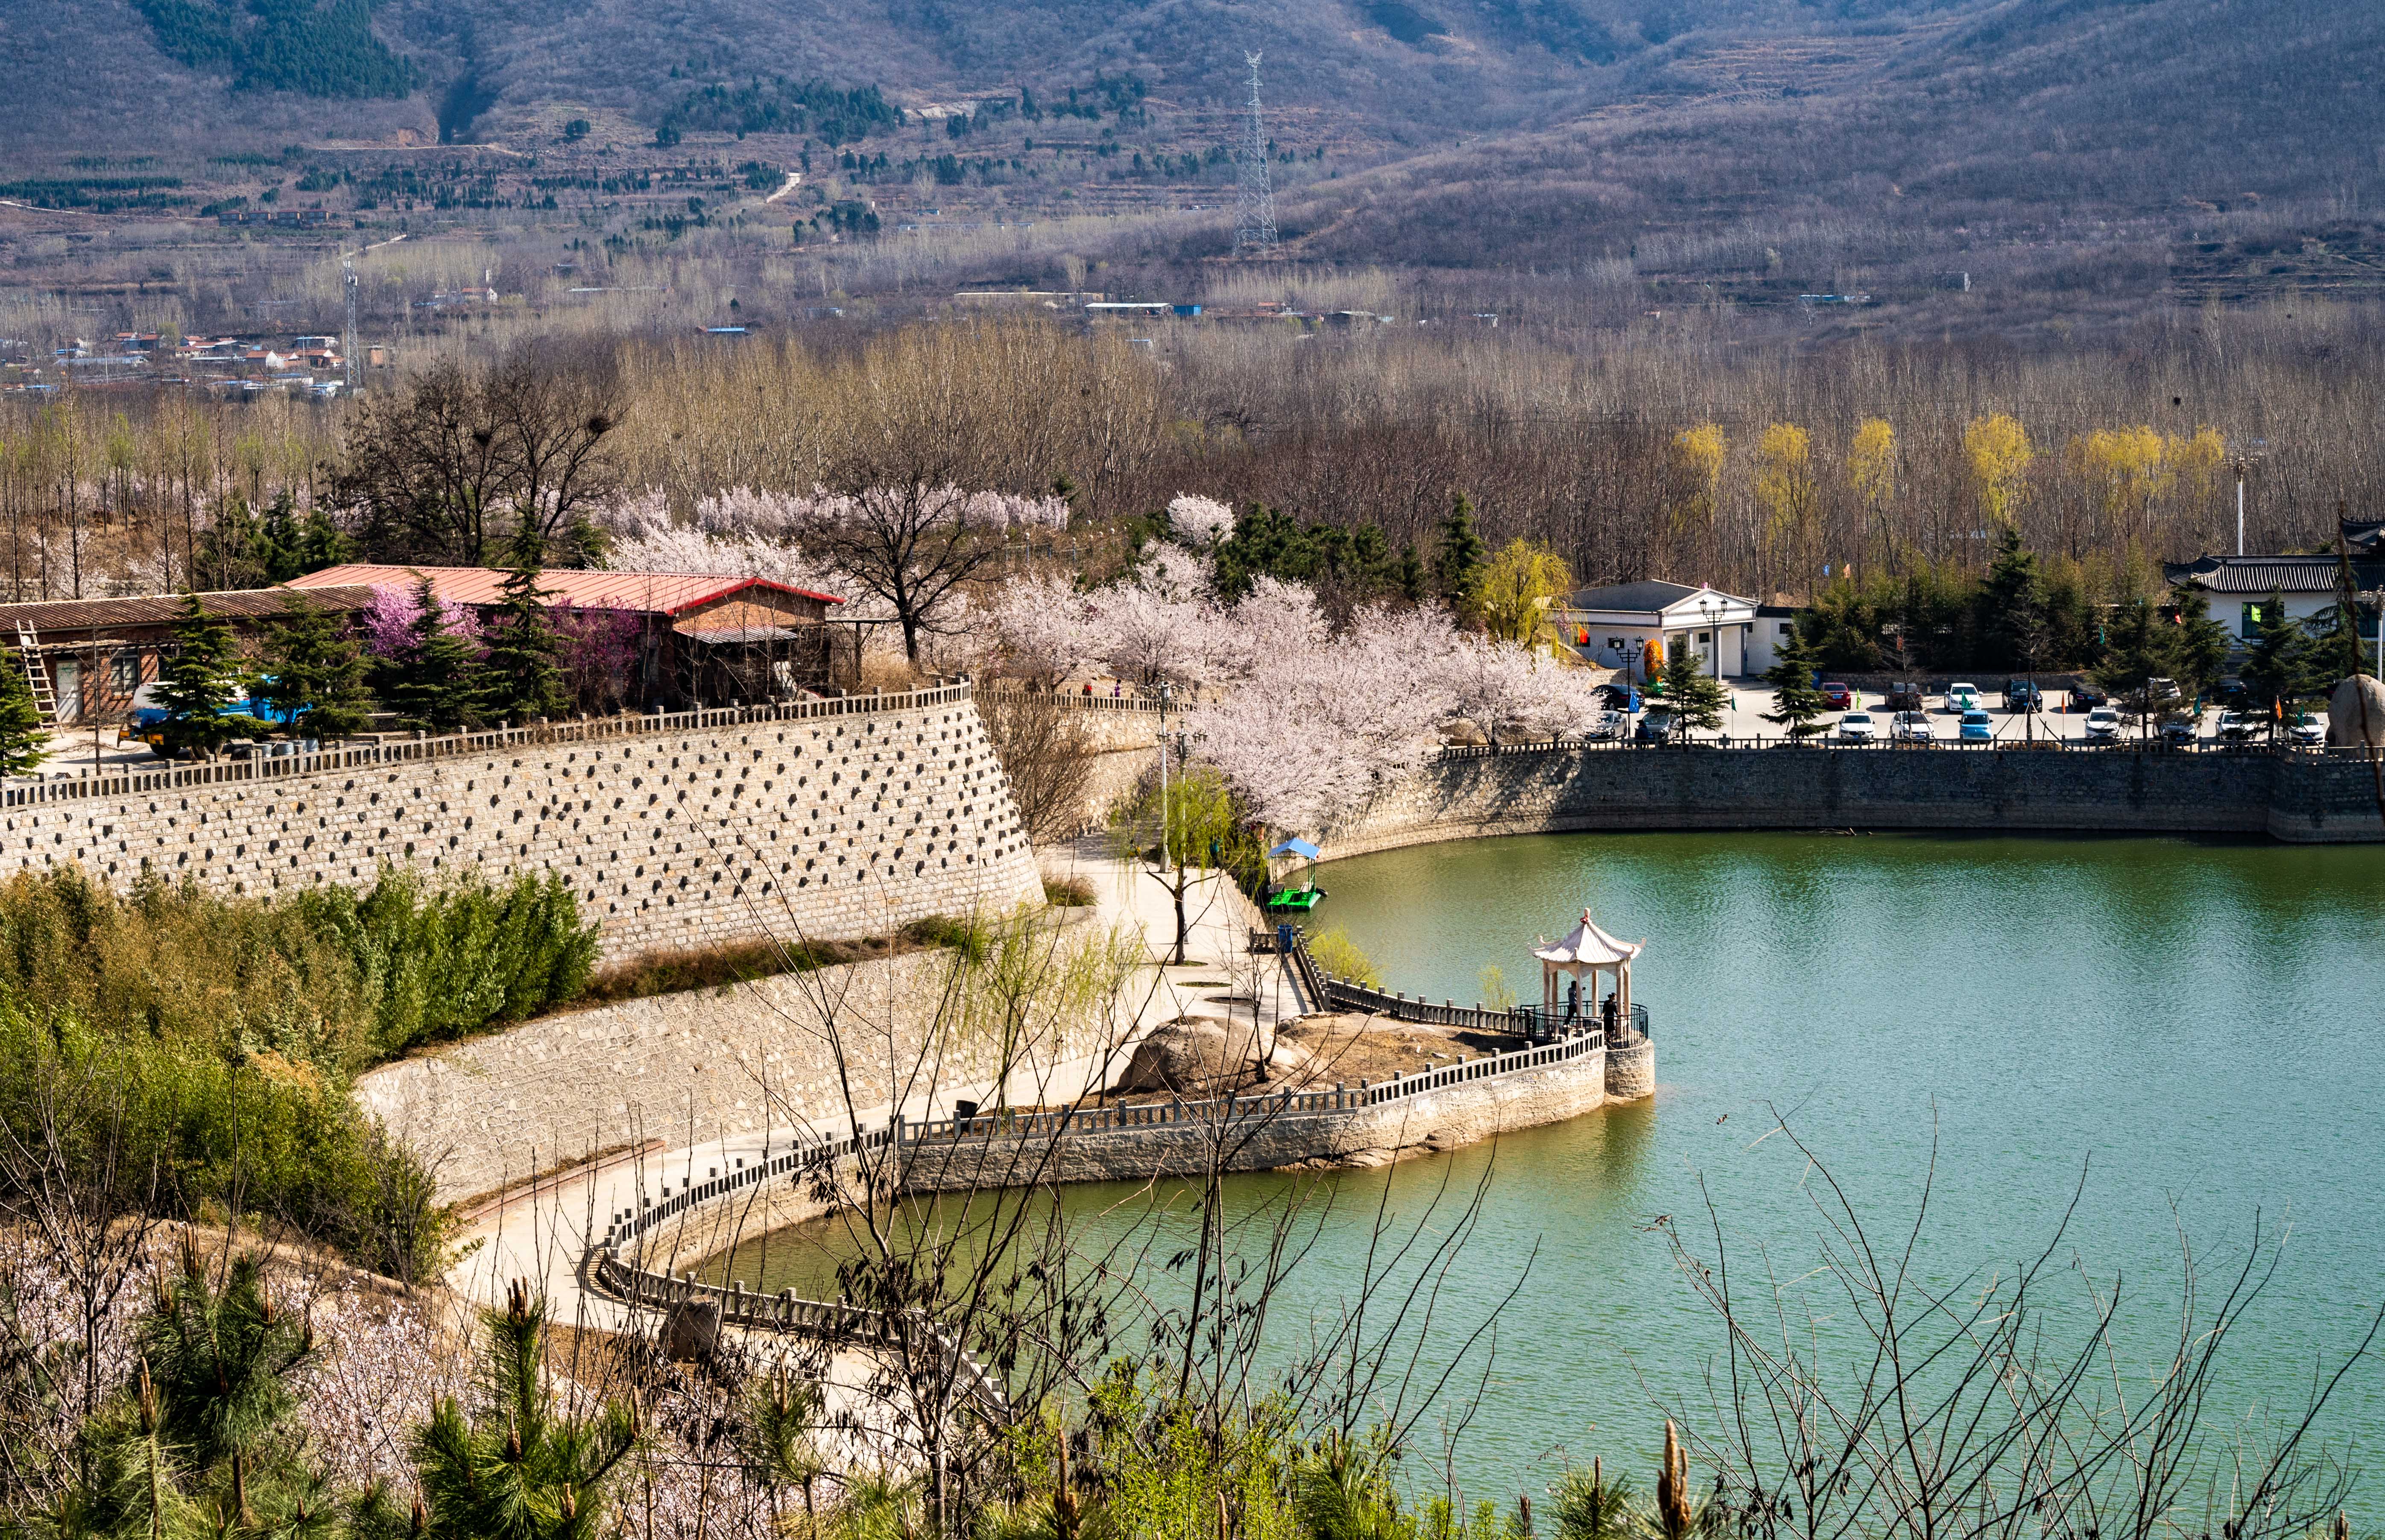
[0,679,971,808]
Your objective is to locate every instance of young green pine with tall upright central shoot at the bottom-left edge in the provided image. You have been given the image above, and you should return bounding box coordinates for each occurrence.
[415,1283,639,1540]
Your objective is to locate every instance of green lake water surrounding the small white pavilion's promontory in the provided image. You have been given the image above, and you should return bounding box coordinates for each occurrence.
[715,834,2385,1521]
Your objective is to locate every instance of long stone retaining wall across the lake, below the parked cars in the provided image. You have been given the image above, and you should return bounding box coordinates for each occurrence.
[1321,746,2385,856]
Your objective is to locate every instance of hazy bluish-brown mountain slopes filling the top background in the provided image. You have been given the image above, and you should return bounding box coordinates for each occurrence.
[0,0,2385,324]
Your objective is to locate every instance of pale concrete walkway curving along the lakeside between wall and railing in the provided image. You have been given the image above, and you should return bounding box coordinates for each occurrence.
[446,842,1302,1330]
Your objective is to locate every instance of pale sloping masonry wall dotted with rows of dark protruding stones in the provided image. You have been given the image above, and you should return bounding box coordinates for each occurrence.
[0,691,1042,958]
